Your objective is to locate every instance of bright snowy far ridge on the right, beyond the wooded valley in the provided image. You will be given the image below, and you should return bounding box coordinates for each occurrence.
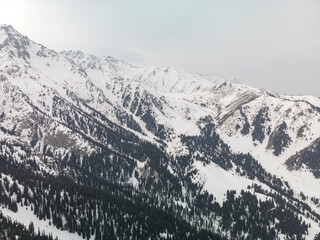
[65,47,320,202]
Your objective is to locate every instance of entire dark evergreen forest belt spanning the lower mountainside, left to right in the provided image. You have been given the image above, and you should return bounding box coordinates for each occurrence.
[0,135,320,240]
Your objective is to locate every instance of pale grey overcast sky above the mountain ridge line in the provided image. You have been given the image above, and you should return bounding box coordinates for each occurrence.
[0,0,320,96]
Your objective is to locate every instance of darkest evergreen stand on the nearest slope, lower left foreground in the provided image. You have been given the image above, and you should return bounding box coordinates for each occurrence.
[0,156,222,240]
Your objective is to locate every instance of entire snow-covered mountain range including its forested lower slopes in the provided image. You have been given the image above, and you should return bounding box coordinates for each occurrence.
[0,25,320,239]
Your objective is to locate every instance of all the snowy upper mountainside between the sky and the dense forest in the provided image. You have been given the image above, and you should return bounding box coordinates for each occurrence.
[0,25,320,239]
